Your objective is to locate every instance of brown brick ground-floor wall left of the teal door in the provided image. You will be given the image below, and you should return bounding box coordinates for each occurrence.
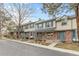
[37,32,58,41]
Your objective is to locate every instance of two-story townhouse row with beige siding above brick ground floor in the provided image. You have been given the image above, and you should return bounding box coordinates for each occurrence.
[23,16,78,43]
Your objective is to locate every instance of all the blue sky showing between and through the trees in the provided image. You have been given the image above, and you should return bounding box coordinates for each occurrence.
[6,3,74,21]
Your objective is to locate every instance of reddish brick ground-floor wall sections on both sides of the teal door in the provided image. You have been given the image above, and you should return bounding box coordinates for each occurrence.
[38,30,73,43]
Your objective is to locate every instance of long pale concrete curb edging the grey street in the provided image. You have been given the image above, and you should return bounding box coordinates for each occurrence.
[4,39,79,55]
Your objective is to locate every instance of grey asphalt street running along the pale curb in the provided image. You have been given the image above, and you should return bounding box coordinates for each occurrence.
[0,40,78,56]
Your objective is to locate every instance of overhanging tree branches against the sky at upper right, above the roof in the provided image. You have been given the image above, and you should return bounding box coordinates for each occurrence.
[42,3,74,18]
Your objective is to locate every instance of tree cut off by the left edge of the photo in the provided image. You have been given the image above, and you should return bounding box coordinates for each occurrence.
[0,3,10,37]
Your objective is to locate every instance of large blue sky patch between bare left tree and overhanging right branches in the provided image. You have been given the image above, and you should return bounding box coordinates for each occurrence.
[31,3,49,20]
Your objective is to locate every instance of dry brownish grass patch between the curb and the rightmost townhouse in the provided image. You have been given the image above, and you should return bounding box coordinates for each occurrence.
[55,43,79,51]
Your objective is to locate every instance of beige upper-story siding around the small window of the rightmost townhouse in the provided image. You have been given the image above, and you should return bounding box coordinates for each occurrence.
[56,19,77,30]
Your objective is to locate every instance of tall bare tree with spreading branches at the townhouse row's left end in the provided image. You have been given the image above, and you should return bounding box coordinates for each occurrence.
[4,3,34,38]
